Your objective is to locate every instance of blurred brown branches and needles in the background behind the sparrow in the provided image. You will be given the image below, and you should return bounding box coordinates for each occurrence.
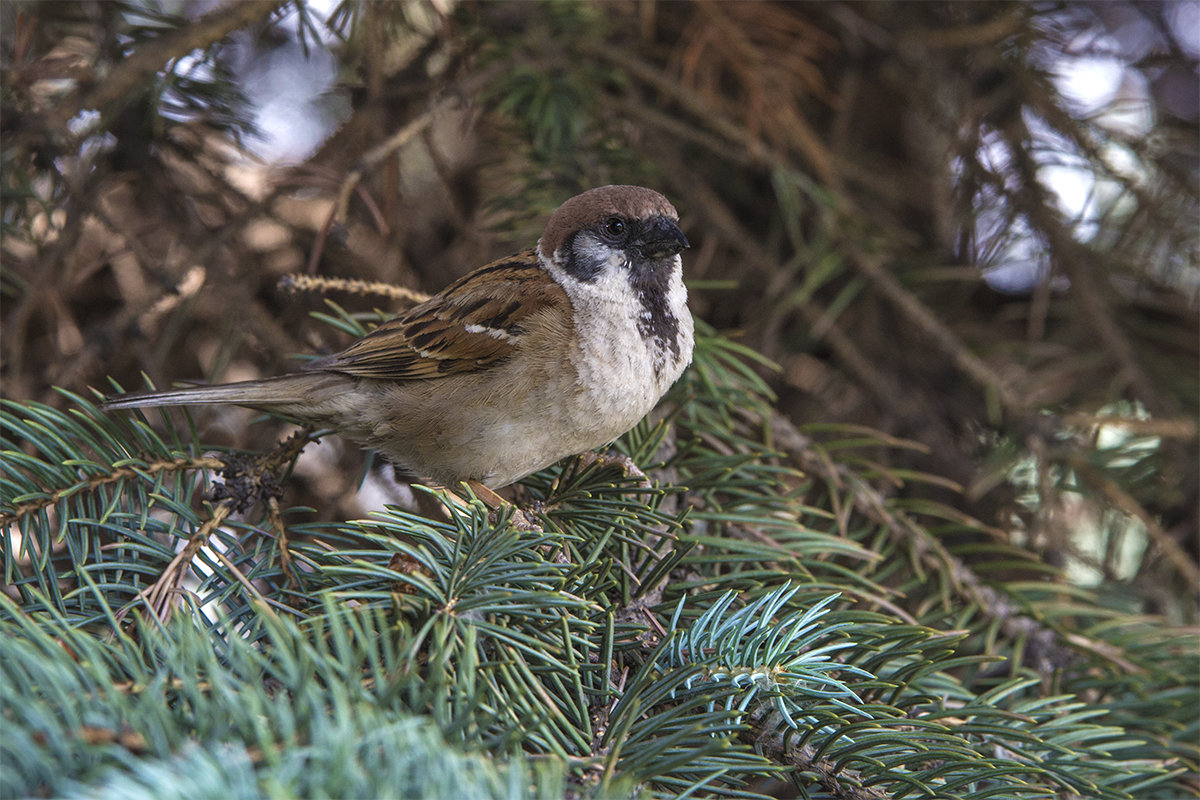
[0,0,1200,796]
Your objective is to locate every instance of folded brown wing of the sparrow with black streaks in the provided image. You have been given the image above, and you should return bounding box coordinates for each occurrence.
[310,249,556,380]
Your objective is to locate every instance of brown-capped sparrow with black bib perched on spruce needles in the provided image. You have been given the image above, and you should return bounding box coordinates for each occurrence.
[103,186,694,489]
